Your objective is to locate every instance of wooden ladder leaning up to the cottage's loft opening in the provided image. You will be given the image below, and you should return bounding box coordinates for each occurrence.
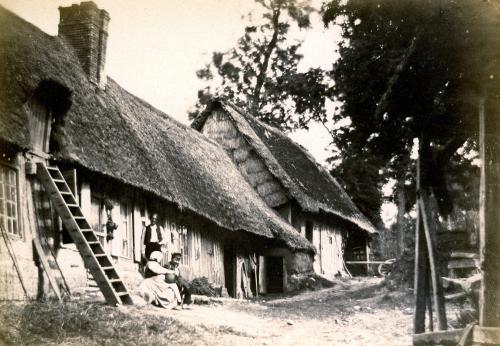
[37,163,133,305]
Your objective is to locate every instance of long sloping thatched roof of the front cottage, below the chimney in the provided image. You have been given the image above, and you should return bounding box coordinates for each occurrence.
[0,7,314,252]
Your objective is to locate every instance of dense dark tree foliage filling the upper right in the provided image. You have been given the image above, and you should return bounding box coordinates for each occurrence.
[323,0,499,222]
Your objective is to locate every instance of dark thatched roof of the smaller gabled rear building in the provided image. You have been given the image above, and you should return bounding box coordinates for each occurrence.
[191,99,377,233]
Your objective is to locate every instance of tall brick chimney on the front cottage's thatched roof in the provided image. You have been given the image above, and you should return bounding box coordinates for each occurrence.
[58,1,109,89]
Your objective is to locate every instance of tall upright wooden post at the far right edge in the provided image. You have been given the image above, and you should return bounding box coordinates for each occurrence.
[479,98,500,327]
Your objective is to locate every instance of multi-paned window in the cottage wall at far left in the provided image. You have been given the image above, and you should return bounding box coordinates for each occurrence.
[0,165,21,236]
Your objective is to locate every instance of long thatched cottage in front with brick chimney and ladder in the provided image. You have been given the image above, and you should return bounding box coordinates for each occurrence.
[0,2,315,302]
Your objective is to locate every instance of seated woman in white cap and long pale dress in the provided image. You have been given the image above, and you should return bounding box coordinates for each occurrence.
[139,251,181,309]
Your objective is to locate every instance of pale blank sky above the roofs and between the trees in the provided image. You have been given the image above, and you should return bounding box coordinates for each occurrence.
[0,0,339,164]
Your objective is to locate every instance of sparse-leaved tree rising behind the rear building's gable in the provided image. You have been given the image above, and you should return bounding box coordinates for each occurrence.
[190,0,328,130]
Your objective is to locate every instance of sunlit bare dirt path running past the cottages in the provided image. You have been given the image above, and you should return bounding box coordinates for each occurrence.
[129,279,412,346]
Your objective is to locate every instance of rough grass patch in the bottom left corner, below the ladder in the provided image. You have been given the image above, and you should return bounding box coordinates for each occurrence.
[0,302,205,346]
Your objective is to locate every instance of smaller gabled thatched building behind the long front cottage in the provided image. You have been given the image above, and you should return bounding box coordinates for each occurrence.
[191,100,376,279]
